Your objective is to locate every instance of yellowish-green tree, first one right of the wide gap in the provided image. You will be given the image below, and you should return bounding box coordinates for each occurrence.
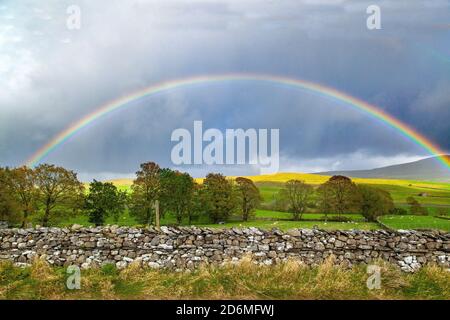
[280,180,313,221]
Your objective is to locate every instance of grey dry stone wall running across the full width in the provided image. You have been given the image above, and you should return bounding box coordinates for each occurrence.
[0,226,450,272]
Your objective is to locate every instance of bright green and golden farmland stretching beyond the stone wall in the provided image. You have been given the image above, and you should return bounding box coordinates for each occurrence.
[6,173,450,231]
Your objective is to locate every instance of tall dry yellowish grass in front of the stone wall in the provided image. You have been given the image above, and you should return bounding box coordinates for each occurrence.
[0,257,450,300]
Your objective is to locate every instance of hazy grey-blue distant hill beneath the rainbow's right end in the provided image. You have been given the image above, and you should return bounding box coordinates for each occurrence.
[316,155,450,182]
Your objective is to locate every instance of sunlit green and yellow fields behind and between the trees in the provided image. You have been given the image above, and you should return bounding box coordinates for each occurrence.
[89,173,450,231]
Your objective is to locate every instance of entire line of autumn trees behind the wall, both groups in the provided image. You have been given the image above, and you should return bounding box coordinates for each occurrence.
[0,162,426,227]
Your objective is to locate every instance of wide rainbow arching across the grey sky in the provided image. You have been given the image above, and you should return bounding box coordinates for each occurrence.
[26,73,450,170]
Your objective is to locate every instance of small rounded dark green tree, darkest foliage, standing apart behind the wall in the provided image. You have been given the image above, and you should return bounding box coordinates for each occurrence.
[85,180,126,226]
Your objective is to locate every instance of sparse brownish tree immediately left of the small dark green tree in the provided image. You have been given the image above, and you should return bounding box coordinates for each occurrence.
[35,164,84,226]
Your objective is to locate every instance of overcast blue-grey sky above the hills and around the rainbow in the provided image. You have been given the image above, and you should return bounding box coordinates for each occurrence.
[0,0,450,179]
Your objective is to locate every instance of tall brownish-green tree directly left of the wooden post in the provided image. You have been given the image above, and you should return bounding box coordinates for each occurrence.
[130,162,161,225]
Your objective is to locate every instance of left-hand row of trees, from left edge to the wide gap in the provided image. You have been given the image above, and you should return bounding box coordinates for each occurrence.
[0,162,261,227]
